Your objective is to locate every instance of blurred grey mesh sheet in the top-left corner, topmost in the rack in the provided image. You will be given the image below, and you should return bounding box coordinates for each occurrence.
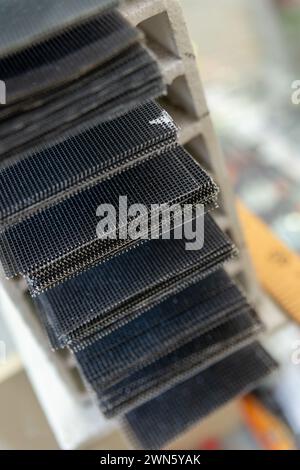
[0,0,118,57]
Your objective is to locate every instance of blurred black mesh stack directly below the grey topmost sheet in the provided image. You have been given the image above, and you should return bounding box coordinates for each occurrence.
[0,11,139,106]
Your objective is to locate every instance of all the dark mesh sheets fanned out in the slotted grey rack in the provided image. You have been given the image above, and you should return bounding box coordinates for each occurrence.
[0,0,275,448]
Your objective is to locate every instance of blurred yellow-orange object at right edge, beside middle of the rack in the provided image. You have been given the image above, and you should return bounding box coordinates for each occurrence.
[237,201,300,323]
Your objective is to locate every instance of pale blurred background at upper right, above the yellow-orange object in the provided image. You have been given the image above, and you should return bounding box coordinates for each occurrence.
[181,0,300,252]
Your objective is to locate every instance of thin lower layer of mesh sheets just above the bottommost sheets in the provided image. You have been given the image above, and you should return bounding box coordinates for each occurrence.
[95,312,260,417]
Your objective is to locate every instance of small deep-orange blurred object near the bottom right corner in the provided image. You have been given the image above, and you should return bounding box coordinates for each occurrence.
[241,395,296,450]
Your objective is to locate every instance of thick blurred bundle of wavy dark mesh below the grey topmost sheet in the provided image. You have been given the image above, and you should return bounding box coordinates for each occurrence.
[0,1,164,163]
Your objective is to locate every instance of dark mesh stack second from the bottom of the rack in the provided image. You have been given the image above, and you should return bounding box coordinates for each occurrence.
[72,271,261,416]
